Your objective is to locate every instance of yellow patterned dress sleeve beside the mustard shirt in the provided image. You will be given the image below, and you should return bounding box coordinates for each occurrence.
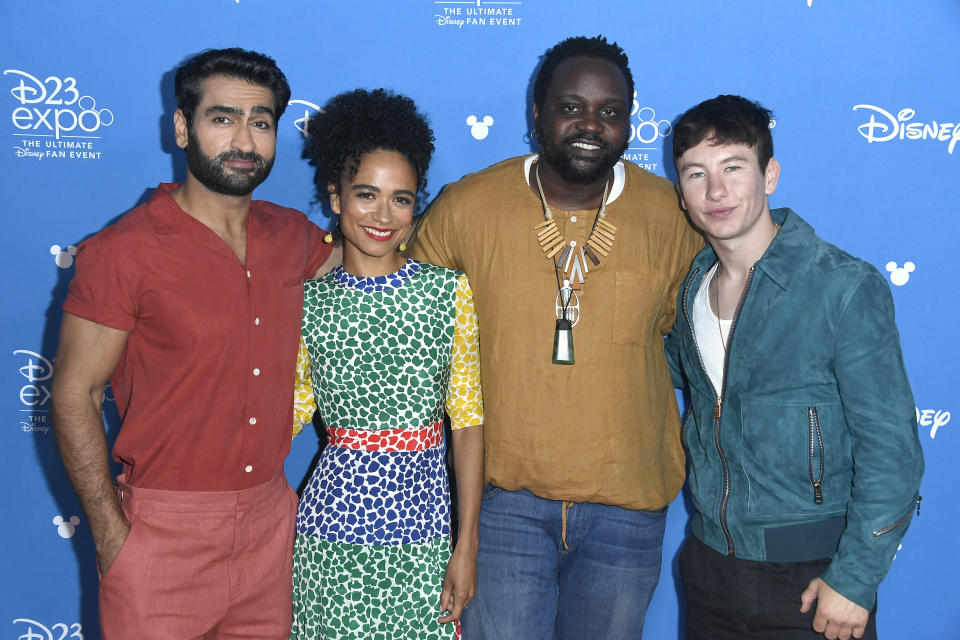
[447,275,483,429]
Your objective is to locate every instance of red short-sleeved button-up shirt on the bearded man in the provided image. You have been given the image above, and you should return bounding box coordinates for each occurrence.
[63,184,330,491]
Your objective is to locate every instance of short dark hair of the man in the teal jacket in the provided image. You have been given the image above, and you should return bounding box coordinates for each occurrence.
[673,95,773,170]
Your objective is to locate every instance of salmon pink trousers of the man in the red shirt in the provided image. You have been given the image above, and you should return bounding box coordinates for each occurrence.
[100,473,297,640]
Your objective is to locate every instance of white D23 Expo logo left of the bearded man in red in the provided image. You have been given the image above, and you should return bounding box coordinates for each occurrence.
[3,69,114,160]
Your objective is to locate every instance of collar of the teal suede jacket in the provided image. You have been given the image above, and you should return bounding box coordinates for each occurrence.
[690,208,814,290]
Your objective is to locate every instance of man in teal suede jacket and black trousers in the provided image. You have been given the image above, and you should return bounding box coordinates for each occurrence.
[667,96,923,640]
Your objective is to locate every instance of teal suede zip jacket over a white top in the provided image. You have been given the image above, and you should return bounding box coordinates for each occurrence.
[667,209,923,609]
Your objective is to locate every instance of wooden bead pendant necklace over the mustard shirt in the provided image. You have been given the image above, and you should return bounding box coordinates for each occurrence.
[534,163,617,364]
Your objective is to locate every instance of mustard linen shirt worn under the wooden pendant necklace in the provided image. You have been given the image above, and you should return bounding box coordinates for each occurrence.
[410,157,703,510]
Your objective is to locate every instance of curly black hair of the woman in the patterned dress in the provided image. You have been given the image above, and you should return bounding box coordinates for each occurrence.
[303,89,434,211]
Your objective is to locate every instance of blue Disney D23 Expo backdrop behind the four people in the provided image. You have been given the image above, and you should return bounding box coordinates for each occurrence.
[0,0,960,640]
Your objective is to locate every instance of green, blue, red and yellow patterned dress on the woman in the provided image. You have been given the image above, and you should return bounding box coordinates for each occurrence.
[291,260,483,640]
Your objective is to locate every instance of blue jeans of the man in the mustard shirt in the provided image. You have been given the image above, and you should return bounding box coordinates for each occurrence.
[462,485,667,640]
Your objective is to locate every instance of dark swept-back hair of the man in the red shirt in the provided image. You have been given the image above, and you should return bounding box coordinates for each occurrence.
[174,47,290,127]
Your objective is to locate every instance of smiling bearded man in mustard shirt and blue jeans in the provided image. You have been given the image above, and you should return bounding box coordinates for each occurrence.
[411,37,702,640]
